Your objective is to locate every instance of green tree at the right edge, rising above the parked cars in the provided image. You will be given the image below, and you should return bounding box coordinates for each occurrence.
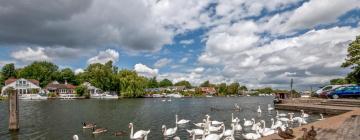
[341,36,360,84]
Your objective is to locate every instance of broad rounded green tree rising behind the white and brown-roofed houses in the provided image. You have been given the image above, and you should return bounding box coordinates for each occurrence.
[19,61,58,87]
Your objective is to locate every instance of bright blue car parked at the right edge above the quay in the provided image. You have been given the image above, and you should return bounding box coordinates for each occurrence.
[327,85,360,99]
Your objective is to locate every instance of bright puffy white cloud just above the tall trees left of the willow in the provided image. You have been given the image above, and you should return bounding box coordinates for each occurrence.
[88,49,119,64]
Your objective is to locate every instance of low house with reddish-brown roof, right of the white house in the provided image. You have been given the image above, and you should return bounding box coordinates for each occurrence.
[45,81,76,95]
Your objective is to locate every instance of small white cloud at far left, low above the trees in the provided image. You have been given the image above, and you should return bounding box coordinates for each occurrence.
[11,47,52,62]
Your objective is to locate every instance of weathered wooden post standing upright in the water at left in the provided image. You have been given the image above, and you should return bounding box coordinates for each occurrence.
[8,89,19,131]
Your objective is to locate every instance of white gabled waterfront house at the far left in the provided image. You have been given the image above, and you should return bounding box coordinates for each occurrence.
[1,78,41,95]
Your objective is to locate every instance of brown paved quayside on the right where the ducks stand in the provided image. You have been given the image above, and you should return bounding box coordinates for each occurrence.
[261,99,360,140]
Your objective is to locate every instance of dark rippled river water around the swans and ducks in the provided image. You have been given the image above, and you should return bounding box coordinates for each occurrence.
[0,97,319,140]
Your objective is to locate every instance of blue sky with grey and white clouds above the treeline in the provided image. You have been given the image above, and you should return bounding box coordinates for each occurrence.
[0,0,360,90]
